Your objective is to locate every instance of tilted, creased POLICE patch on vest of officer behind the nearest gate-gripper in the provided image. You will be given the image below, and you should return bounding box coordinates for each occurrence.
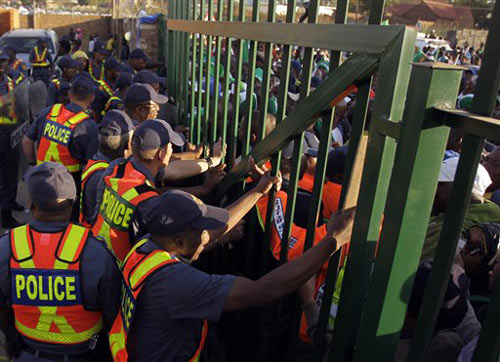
[99,187,135,231]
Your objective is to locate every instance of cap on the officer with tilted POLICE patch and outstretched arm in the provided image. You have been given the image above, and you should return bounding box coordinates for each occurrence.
[132,119,184,151]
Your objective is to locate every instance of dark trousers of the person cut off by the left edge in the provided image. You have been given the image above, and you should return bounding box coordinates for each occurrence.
[0,129,20,210]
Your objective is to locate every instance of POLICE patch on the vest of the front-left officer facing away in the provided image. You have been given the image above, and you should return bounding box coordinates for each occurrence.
[11,269,82,307]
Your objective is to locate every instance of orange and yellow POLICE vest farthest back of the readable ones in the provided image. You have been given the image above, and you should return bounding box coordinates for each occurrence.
[36,103,89,173]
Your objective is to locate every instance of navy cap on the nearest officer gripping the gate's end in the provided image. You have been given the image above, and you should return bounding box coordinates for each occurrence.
[146,190,229,236]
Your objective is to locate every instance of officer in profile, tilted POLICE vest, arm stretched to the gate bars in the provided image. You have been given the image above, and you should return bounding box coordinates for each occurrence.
[92,119,223,261]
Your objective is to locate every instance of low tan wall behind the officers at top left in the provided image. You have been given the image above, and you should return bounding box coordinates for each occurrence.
[19,14,111,49]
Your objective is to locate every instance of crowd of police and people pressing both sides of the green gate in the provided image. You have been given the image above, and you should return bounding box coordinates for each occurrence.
[0,26,500,362]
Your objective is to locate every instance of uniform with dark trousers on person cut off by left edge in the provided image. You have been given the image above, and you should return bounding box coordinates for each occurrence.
[0,74,19,219]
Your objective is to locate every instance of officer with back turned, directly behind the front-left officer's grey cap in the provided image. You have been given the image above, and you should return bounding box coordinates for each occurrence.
[23,75,97,221]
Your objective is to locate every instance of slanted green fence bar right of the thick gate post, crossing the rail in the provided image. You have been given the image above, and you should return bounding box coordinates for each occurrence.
[410,1,500,362]
